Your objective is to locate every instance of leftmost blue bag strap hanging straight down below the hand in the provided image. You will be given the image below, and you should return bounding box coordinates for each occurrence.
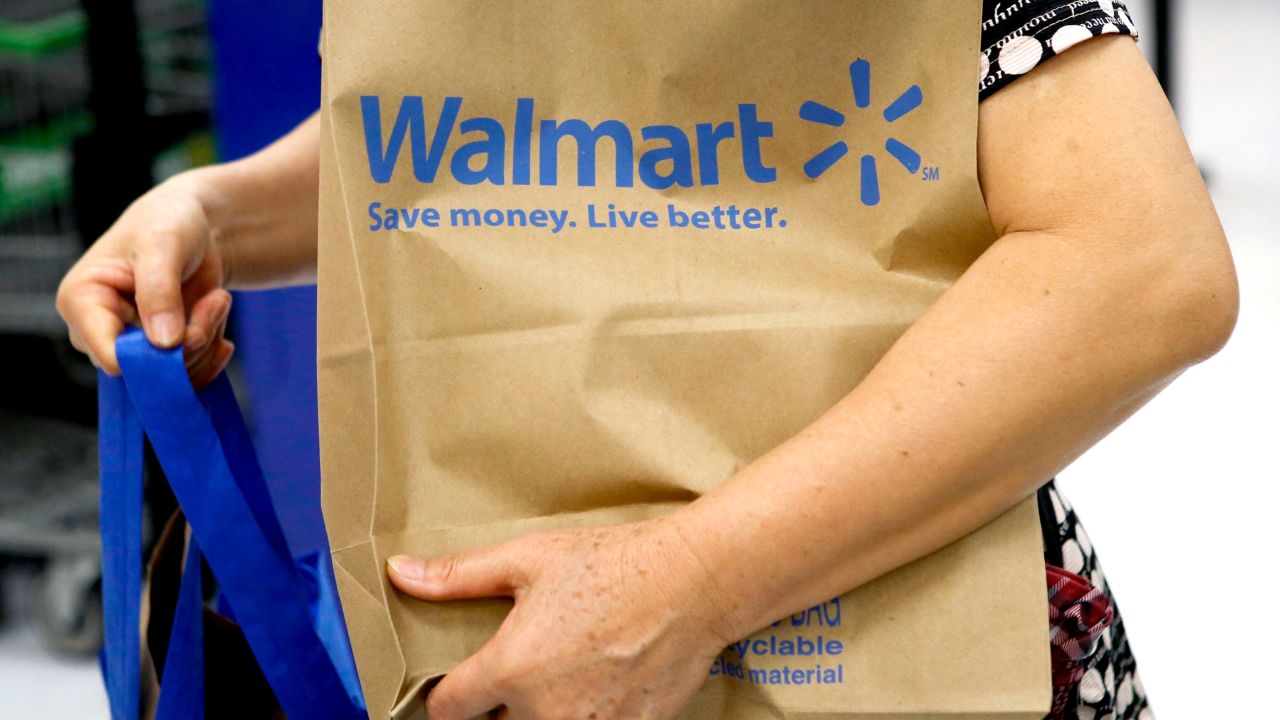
[97,373,142,720]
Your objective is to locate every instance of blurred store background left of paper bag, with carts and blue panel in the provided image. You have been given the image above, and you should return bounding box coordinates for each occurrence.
[0,0,323,707]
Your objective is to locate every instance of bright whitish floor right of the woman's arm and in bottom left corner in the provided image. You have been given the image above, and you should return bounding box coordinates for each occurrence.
[0,0,1280,720]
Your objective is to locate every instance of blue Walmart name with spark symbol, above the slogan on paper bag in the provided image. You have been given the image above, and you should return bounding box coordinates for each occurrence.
[360,60,938,198]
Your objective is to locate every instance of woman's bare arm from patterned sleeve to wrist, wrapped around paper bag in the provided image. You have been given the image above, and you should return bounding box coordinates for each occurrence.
[676,37,1238,639]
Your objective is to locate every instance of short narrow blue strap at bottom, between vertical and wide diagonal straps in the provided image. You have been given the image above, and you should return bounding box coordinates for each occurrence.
[156,537,205,720]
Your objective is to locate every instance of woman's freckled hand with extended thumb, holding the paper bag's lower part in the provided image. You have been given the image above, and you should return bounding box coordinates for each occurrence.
[388,520,728,720]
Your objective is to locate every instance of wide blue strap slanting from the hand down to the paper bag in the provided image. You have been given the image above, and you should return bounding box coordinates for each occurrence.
[104,329,366,720]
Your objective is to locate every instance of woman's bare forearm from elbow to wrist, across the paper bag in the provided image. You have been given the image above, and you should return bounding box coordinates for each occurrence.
[677,219,1234,638]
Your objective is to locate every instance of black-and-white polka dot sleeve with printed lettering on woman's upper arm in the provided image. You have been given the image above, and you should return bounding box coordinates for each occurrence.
[978,0,1138,100]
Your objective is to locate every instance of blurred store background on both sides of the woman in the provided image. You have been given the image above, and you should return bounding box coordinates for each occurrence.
[0,0,1280,720]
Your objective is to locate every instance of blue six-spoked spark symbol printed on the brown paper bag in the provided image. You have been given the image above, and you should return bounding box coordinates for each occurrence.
[800,60,924,205]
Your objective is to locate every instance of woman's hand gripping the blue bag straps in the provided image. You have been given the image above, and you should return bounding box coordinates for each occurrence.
[58,170,234,387]
